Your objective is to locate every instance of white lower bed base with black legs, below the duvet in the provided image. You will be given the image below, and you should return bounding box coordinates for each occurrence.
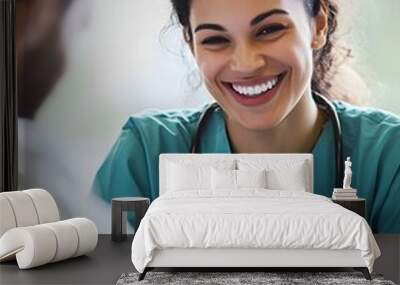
[139,248,371,280]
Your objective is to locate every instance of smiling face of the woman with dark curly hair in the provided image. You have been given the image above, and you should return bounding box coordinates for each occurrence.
[190,0,324,130]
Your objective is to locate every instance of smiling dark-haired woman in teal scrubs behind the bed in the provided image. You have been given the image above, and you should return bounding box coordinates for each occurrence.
[93,0,400,233]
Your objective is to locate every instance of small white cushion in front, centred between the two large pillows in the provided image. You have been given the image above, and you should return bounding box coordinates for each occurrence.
[211,168,267,190]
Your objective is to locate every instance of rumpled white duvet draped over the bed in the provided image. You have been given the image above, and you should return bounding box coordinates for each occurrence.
[132,189,380,272]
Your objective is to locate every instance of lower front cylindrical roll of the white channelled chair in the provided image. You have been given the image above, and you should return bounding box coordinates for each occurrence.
[0,218,98,269]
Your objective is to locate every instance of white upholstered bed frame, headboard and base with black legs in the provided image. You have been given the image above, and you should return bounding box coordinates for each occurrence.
[139,154,371,280]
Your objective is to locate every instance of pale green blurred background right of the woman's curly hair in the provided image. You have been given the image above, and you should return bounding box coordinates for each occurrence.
[338,0,400,112]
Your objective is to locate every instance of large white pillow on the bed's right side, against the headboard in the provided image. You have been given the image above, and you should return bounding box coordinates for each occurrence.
[238,159,312,191]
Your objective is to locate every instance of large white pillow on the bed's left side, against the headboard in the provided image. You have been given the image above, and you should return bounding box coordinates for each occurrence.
[166,160,236,191]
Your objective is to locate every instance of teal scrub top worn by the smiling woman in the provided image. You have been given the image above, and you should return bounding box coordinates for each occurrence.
[92,101,400,233]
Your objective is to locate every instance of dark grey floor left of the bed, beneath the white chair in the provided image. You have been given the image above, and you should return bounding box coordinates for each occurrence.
[0,235,135,285]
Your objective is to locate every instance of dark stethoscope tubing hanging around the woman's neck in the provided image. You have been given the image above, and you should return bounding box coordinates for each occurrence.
[191,92,344,188]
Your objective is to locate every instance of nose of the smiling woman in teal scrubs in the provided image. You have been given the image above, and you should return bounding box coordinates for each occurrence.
[230,43,266,73]
